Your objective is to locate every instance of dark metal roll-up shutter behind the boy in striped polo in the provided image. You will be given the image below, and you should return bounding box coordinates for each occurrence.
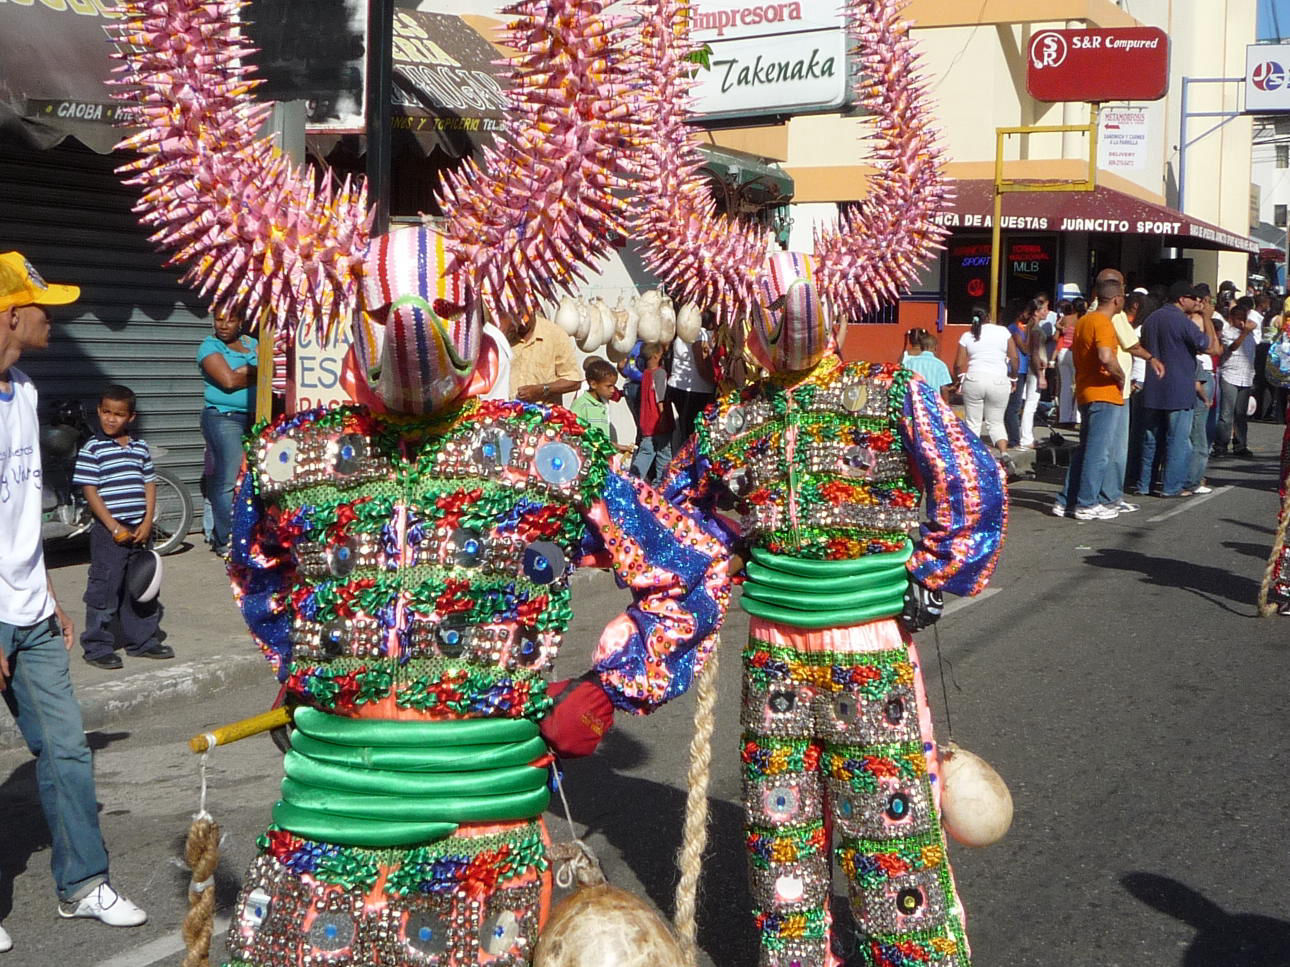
[0,142,210,515]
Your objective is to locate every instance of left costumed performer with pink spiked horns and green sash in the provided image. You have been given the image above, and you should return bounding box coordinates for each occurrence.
[117,0,729,967]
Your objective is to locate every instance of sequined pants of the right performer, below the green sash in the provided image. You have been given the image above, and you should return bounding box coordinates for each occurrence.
[743,618,970,967]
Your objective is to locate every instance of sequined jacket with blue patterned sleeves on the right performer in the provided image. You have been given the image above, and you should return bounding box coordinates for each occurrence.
[666,353,1007,582]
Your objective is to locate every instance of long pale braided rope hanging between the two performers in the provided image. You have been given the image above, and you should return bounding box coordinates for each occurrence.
[676,638,721,967]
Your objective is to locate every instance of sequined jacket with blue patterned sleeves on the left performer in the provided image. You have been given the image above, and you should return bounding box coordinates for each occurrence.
[231,401,729,719]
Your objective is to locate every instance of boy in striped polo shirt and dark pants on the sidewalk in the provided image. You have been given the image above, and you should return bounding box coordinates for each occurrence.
[72,386,174,668]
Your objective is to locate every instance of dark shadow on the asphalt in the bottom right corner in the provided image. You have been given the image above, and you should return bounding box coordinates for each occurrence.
[1120,873,1290,967]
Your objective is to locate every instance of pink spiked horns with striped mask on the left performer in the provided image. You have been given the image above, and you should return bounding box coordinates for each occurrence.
[110,0,633,413]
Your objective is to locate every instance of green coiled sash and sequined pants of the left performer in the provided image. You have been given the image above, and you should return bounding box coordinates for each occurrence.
[228,709,551,967]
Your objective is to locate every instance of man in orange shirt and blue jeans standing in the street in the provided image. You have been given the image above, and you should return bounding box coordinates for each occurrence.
[1053,277,1125,521]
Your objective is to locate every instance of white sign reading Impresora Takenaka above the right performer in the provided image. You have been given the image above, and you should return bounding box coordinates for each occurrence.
[690,0,849,119]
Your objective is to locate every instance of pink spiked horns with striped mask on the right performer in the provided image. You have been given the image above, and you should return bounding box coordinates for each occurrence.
[632,0,947,371]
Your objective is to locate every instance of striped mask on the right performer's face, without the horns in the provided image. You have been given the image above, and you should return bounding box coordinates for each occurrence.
[748,251,833,373]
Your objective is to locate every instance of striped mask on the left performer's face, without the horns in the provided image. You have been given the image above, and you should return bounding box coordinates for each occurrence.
[353,226,484,414]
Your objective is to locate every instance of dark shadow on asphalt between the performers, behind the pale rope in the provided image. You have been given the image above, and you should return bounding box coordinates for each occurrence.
[552,731,757,967]
